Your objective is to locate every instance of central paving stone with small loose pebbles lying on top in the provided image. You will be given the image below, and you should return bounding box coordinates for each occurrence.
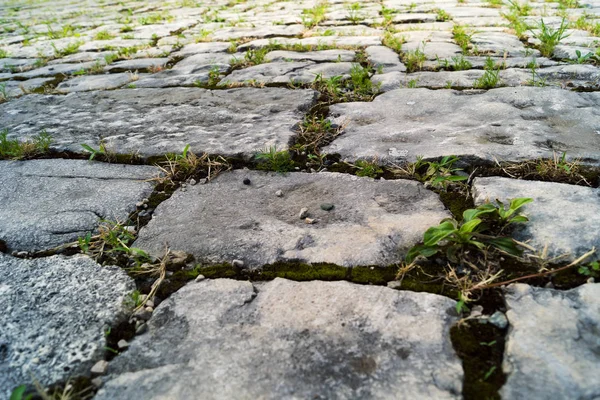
[135,170,448,267]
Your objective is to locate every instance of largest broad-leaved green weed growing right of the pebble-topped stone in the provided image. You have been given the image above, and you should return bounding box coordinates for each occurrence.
[406,198,532,264]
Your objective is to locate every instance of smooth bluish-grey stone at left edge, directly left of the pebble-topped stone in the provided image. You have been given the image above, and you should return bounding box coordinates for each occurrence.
[0,159,160,251]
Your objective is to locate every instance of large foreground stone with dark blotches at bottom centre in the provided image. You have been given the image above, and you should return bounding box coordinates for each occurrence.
[96,278,463,400]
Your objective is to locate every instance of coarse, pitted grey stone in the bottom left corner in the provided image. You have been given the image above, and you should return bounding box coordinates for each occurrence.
[0,253,135,399]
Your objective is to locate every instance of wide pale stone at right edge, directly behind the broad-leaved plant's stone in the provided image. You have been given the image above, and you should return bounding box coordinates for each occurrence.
[324,87,600,165]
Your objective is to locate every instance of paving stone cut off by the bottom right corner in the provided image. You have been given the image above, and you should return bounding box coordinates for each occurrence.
[500,283,600,400]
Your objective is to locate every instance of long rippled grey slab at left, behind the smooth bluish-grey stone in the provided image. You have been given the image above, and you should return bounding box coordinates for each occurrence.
[0,88,317,157]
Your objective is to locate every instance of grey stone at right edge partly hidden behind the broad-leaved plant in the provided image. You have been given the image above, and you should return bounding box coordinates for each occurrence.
[473,177,600,260]
